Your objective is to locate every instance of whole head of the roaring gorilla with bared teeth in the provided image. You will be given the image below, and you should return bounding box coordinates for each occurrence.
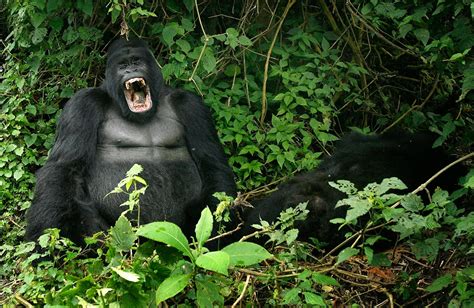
[104,39,163,122]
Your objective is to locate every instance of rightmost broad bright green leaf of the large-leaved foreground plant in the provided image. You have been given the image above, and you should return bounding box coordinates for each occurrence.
[222,242,272,266]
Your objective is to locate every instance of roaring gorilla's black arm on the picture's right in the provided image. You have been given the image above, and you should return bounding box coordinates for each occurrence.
[171,90,236,206]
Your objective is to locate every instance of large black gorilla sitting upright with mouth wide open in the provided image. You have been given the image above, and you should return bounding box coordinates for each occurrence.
[26,39,236,243]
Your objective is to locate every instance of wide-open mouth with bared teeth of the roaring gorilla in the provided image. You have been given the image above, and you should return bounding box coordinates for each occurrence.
[124,77,152,113]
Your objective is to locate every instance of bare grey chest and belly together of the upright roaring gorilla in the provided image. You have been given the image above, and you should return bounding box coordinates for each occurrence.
[87,98,202,223]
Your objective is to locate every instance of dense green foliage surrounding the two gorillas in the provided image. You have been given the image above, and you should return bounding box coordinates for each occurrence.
[0,0,474,307]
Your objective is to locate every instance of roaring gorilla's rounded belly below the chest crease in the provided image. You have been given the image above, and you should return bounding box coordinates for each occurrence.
[87,146,202,225]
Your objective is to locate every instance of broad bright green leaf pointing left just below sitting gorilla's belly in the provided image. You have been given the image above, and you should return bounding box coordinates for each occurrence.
[137,221,194,260]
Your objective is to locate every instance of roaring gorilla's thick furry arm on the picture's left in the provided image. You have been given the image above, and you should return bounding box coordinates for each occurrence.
[26,88,107,242]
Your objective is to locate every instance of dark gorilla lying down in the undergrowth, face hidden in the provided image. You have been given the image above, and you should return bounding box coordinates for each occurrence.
[239,132,464,247]
